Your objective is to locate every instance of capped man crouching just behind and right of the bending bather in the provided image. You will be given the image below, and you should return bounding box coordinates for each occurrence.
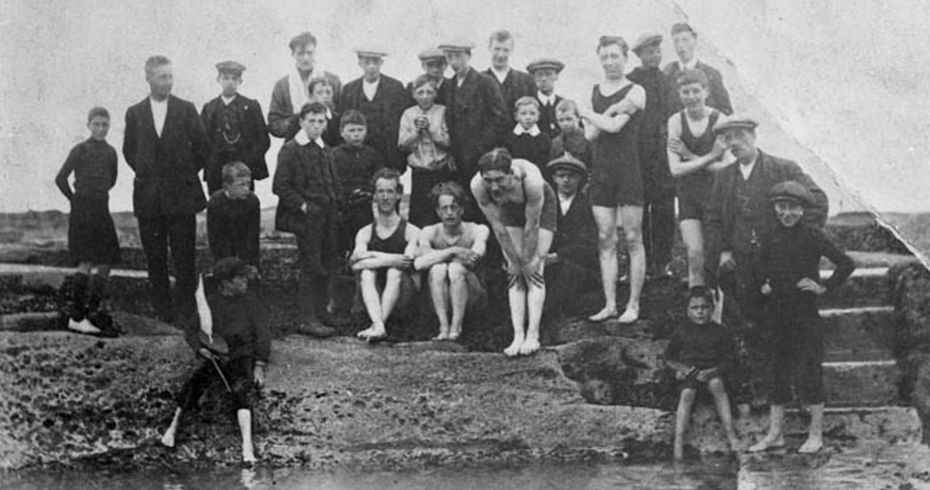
[543,153,599,319]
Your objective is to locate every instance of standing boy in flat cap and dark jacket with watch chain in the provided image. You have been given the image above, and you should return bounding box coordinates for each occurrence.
[200,61,271,195]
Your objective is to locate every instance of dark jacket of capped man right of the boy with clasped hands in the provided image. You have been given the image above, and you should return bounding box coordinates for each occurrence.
[446,68,513,179]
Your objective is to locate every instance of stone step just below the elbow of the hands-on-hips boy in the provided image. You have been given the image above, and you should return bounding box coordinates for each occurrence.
[820,306,896,361]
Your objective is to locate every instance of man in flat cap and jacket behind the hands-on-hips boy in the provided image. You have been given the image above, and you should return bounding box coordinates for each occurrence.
[704,115,828,406]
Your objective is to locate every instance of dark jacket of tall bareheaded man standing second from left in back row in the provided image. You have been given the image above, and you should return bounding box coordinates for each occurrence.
[123,95,210,217]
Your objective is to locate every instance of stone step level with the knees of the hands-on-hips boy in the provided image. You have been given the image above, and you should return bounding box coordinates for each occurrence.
[823,360,902,407]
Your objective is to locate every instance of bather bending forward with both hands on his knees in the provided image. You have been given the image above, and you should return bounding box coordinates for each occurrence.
[471,148,558,356]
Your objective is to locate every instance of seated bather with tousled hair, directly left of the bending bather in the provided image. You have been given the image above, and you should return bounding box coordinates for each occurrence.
[413,182,490,340]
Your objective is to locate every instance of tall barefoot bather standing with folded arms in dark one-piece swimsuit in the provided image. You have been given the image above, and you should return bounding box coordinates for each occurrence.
[579,36,646,323]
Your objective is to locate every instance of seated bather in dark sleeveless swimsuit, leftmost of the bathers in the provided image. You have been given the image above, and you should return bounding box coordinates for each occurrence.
[349,168,420,341]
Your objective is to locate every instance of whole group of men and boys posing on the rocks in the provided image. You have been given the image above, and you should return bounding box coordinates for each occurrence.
[56,23,853,461]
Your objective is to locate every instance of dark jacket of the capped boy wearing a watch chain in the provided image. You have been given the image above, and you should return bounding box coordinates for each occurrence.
[200,94,271,180]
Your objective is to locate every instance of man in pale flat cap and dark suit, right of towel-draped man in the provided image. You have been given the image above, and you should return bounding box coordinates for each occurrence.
[337,48,414,172]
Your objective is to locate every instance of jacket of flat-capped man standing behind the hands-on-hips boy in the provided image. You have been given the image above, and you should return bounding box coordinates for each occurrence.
[704,151,829,267]
